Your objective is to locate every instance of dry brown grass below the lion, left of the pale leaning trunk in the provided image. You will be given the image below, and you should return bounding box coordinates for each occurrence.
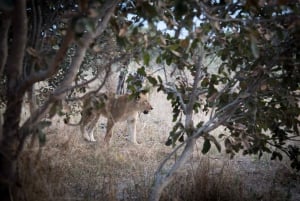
[16,124,167,201]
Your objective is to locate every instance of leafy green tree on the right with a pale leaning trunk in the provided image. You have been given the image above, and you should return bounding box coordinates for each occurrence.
[144,1,300,200]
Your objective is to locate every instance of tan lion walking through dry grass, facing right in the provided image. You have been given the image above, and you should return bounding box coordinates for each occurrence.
[69,93,153,145]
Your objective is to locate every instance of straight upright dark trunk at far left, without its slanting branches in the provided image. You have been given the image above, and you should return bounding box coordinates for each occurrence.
[0,0,27,201]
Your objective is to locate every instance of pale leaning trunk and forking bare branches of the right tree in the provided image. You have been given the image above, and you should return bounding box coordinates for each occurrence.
[149,57,262,201]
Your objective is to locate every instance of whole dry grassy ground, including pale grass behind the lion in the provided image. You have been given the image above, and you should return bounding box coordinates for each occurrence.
[14,91,300,201]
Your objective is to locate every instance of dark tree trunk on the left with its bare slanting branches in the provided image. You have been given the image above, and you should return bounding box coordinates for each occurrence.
[0,0,119,201]
